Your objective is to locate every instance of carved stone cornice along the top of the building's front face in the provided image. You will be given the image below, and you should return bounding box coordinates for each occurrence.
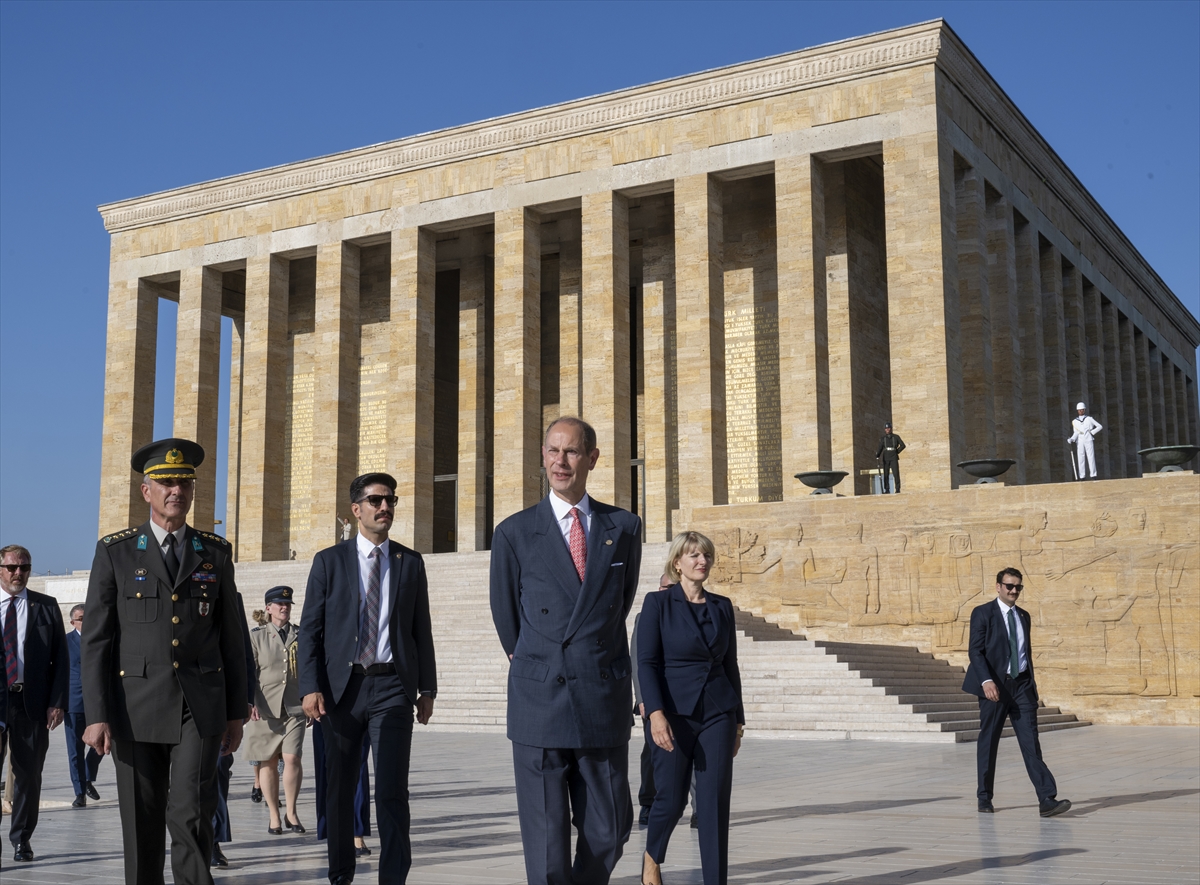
[100,20,943,233]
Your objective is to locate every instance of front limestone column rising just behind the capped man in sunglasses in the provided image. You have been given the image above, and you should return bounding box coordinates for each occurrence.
[388,228,437,553]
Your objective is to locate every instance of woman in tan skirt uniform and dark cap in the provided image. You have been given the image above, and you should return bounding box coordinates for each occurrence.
[242,586,308,836]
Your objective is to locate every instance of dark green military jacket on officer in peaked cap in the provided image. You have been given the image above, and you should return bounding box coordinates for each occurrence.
[80,522,246,743]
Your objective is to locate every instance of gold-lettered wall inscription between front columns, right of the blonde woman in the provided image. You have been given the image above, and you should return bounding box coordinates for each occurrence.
[725,303,784,504]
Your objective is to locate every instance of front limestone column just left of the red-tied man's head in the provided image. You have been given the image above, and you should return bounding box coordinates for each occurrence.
[492,206,542,523]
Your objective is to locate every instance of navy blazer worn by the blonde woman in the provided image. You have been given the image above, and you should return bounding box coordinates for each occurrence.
[637,584,746,724]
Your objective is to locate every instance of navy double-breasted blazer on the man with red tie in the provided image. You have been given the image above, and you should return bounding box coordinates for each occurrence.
[491,496,642,748]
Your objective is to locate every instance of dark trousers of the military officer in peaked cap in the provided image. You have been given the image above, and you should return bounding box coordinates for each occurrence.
[113,705,221,885]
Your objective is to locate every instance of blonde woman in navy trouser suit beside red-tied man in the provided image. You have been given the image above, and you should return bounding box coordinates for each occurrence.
[637,531,745,885]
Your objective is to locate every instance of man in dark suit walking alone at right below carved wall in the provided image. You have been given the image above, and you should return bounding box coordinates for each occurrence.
[962,568,1070,818]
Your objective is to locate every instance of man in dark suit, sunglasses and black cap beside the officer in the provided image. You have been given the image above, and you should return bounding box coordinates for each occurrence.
[298,474,438,885]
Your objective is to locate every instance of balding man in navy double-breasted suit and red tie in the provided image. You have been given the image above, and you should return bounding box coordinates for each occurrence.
[491,417,642,885]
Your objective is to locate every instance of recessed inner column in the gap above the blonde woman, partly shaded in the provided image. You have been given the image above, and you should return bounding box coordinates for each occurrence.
[638,219,679,543]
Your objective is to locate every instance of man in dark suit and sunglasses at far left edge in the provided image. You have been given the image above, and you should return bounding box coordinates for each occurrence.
[0,544,68,862]
